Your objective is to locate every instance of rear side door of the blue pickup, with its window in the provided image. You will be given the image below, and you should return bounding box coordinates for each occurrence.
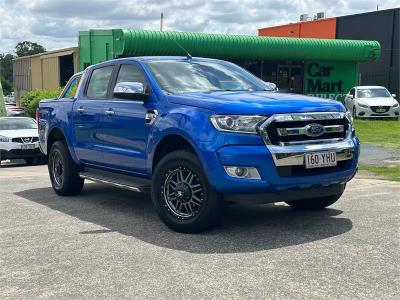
[72,65,115,166]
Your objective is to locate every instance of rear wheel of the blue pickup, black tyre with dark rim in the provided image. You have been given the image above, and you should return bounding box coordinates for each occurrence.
[48,141,84,196]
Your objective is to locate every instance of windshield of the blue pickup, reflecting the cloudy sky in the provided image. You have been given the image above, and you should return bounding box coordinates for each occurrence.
[146,60,271,94]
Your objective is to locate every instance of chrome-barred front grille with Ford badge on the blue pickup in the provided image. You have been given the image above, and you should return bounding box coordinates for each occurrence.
[260,113,350,146]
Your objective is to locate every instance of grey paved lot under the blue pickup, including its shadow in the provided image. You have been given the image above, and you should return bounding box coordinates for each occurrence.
[0,166,400,299]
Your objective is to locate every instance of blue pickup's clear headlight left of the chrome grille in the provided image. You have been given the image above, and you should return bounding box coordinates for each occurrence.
[210,115,267,134]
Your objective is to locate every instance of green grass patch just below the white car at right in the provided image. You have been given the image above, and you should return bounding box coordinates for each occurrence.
[354,119,400,151]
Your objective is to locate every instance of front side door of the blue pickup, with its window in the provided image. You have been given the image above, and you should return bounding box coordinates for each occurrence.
[103,62,154,174]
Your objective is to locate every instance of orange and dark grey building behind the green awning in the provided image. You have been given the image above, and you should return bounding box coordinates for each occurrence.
[258,8,400,95]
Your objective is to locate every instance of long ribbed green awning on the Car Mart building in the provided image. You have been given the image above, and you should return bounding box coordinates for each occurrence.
[112,29,381,62]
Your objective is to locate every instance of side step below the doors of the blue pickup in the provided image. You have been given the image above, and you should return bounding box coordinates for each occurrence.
[79,168,151,192]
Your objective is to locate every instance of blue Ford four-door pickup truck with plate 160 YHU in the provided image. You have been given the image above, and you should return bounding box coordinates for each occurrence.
[37,56,359,232]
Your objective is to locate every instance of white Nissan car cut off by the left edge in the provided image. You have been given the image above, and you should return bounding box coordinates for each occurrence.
[0,117,43,164]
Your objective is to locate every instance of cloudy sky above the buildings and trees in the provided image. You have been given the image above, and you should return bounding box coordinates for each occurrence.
[0,0,400,53]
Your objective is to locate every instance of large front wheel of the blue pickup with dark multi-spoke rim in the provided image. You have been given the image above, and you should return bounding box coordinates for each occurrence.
[151,151,223,233]
